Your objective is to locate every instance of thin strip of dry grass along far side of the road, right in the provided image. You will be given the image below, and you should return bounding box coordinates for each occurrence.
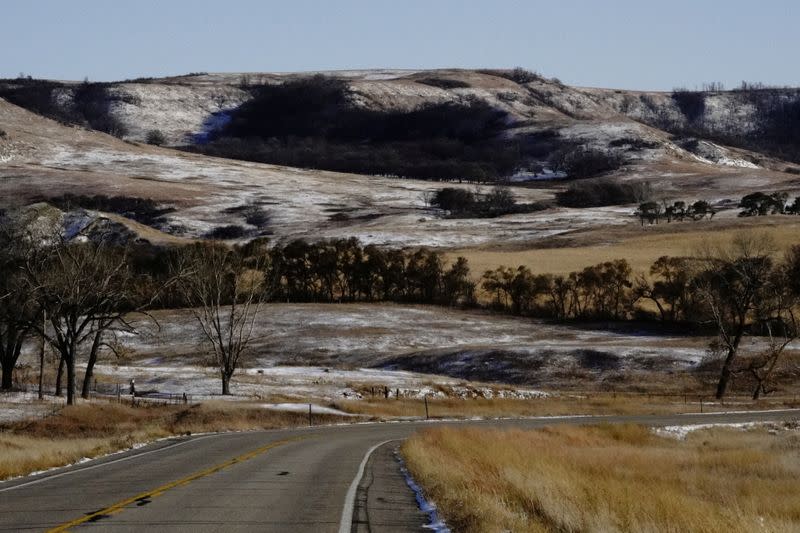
[333,392,796,418]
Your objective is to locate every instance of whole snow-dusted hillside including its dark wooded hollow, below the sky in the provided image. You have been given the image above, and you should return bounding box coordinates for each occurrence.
[0,70,800,256]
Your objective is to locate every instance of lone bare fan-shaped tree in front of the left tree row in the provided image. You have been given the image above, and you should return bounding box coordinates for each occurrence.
[173,243,268,394]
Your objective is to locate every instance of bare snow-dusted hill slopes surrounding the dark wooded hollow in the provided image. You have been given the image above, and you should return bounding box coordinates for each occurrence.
[0,70,800,255]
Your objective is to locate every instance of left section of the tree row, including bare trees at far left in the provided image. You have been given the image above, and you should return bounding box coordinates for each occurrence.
[0,220,475,404]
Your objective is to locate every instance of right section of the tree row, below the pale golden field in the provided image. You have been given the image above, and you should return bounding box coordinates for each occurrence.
[482,235,800,399]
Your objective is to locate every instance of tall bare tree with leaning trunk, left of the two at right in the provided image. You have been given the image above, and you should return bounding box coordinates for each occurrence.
[694,233,773,399]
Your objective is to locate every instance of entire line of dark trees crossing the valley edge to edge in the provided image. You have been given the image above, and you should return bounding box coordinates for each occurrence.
[0,210,800,403]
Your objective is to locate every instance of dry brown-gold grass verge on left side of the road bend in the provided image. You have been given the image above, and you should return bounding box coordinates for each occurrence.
[0,401,346,480]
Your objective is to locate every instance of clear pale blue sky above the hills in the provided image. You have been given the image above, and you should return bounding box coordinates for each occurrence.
[0,0,800,90]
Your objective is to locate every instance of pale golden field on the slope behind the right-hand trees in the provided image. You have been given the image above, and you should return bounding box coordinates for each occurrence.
[446,216,800,278]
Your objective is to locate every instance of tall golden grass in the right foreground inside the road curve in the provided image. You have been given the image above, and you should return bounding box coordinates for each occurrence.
[402,426,800,533]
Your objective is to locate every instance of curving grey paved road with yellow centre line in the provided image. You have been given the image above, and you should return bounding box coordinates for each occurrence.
[0,410,800,532]
